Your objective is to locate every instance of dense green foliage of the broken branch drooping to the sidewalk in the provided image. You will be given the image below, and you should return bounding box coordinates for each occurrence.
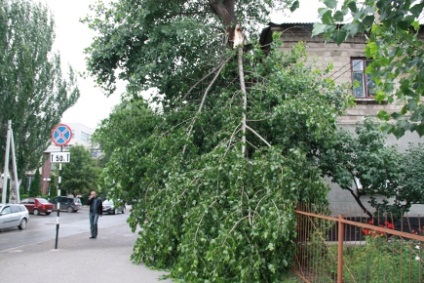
[96,47,350,282]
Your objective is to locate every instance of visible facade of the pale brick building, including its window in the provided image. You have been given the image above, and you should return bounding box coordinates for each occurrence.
[261,22,424,215]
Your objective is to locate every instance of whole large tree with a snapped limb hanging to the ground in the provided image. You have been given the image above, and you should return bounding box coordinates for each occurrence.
[87,0,349,282]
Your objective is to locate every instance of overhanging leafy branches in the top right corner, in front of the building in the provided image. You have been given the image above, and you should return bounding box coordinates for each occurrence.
[313,0,424,137]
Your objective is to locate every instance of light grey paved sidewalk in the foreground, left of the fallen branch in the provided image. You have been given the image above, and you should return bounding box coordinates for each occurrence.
[0,224,172,283]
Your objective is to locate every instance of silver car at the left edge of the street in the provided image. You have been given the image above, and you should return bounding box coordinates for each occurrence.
[0,204,29,230]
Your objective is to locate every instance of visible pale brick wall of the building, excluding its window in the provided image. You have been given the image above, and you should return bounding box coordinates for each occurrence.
[264,23,424,215]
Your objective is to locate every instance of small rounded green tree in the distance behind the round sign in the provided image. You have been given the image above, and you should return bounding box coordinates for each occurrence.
[61,145,101,195]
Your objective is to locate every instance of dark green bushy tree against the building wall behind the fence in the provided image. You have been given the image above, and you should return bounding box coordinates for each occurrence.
[320,120,424,218]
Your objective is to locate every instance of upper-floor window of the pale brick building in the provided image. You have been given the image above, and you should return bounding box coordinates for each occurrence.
[351,58,375,98]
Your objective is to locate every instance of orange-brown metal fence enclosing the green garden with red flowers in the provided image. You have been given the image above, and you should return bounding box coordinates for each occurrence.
[294,207,424,283]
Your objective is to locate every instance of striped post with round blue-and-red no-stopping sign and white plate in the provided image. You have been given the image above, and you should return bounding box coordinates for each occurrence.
[50,124,72,249]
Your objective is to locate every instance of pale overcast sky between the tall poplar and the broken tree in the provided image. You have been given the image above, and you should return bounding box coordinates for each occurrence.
[42,0,123,128]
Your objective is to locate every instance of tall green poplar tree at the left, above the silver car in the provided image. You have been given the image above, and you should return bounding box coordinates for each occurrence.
[0,0,79,176]
